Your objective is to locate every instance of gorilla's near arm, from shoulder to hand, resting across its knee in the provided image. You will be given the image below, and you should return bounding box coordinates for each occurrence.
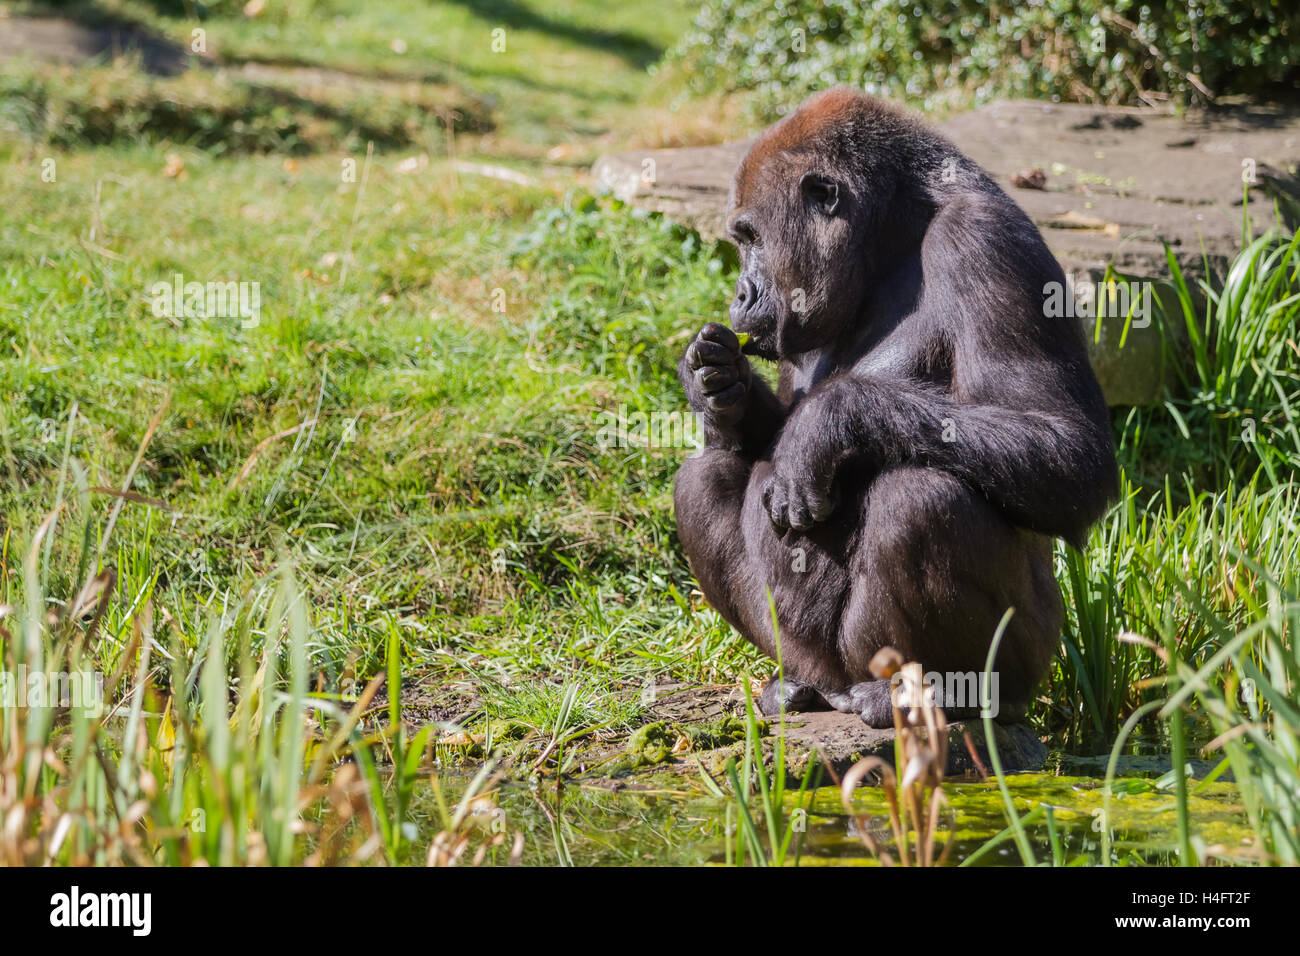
[764,196,1117,544]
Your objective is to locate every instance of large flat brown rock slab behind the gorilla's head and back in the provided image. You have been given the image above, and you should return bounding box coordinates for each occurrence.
[592,100,1300,405]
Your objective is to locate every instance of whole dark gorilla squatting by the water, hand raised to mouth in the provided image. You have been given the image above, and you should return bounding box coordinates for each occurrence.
[673,88,1118,727]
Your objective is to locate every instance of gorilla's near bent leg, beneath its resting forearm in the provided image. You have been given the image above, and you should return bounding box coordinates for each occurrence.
[823,467,1062,727]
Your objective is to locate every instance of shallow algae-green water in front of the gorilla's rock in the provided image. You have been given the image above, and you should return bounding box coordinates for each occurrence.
[413,773,1249,866]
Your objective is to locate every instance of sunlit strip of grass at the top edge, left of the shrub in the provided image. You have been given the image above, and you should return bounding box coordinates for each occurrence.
[9,0,692,163]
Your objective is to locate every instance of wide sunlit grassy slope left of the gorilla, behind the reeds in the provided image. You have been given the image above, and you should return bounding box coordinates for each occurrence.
[0,140,759,712]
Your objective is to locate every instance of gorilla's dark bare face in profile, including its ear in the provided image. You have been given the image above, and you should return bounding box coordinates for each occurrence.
[727,158,867,359]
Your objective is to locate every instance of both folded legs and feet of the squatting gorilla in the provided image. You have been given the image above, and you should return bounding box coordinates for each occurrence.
[675,463,1062,727]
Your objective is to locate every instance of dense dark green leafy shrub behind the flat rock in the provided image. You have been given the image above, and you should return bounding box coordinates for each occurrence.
[670,0,1300,116]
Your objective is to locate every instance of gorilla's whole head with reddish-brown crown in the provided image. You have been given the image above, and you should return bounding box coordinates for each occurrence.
[727,88,941,359]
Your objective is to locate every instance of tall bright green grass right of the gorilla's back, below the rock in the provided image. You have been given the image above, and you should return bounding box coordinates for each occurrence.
[1052,233,1300,740]
